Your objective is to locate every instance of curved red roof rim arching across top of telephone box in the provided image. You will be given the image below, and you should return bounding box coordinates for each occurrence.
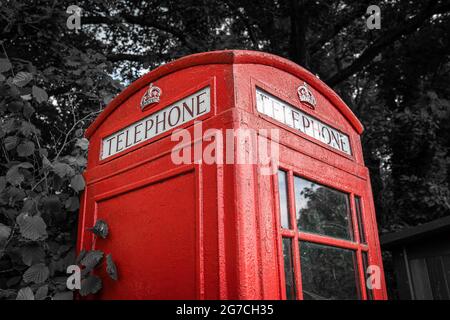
[85,50,364,138]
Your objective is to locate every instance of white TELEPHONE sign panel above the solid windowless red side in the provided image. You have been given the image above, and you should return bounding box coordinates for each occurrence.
[100,87,211,160]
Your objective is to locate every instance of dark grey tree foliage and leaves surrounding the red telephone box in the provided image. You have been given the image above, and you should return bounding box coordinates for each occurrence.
[0,0,450,299]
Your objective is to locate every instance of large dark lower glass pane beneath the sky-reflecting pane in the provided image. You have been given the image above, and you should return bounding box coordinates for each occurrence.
[300,241,360,300]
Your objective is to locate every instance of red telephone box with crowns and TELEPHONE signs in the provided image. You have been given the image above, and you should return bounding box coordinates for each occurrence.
[78,51,386,299]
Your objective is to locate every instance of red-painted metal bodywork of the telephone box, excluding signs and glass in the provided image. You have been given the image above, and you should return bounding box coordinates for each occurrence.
[77,51,386,299]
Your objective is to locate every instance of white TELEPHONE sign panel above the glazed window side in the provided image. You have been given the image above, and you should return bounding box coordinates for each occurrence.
[256,88,352,155]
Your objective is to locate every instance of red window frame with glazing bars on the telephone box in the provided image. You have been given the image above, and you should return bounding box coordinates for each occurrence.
[273,168,374,300]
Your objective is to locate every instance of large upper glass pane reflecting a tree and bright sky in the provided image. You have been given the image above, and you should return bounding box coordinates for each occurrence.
[294,177,353,240]
